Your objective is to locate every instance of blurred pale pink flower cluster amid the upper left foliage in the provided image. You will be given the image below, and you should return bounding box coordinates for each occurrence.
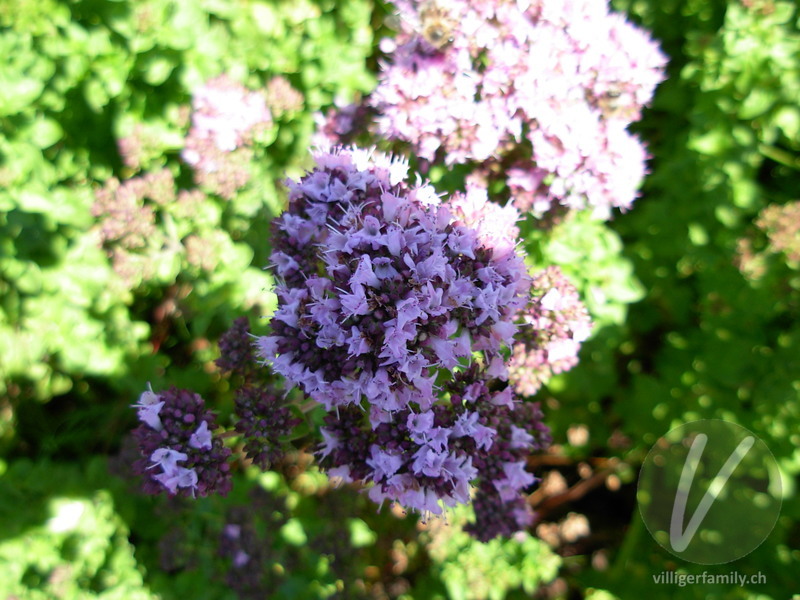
[181,75,272,199]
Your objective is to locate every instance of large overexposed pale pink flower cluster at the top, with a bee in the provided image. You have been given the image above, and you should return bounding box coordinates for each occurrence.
[322,0,666,217]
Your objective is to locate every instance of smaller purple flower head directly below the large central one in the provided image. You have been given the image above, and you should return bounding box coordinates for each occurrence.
[319,365,549,538]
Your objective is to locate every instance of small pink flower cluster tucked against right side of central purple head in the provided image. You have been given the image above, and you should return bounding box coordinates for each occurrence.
[508,266,592,396]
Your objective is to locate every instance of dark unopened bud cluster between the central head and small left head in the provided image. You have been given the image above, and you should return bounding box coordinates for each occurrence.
[217,317,302,469]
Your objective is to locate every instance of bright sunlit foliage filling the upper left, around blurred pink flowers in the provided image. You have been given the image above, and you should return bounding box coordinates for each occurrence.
[0,0,373,408]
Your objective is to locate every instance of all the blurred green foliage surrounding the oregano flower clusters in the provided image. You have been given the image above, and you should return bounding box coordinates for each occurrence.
[0,0,800,600]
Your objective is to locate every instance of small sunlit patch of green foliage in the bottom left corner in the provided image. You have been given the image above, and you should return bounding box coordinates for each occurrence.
[0,460,156,600]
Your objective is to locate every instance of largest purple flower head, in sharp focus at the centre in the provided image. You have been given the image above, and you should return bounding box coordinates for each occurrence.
[258,149,529,414]
